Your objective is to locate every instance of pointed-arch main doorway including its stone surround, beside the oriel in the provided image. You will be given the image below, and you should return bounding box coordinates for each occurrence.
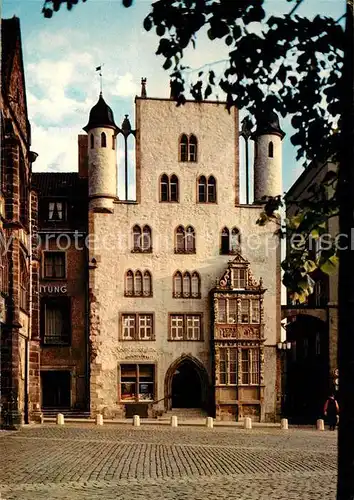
[165,356,209,409]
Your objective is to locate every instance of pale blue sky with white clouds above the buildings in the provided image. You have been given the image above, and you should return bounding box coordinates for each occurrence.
[2,0,345,202]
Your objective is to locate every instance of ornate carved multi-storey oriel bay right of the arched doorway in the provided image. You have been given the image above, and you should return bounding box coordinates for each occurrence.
[212,255,266,420]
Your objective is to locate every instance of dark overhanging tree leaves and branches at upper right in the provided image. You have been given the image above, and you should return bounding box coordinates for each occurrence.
[43,0,346,302]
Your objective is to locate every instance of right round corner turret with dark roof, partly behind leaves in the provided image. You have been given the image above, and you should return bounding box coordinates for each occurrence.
[253,111,285,203]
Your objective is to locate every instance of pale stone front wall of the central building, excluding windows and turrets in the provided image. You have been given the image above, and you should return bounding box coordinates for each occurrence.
[90,99,279,415]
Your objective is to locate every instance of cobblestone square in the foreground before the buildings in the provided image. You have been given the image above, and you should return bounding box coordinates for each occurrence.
[0,425,337,500]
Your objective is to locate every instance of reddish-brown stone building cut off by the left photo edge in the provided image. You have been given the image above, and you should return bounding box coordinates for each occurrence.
[0,17,40,428]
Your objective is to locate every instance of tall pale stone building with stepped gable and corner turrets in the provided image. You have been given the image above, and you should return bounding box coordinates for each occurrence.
[85,91,283,421]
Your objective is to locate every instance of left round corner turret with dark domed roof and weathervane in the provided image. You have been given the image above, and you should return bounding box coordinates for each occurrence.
[83,92,118,213]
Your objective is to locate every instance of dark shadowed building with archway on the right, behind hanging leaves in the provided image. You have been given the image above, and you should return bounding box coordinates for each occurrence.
[282,161,339,423]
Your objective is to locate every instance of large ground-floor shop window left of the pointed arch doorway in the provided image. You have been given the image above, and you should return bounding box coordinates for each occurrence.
[120,364,155,402]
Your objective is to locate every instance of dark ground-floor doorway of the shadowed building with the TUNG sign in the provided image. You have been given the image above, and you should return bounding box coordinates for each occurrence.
[41,371,71,408]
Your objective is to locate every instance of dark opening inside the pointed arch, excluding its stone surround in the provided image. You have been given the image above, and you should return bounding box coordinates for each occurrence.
[172,360,202,408]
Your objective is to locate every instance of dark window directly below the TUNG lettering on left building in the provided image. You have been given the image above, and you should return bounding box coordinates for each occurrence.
[41,297,71,345]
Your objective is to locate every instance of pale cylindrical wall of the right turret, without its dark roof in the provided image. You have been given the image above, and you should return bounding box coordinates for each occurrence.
[254,134,283,200]
